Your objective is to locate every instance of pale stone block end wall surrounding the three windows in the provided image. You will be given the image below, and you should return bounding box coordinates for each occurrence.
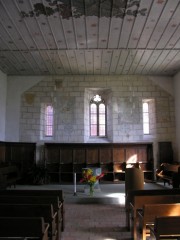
[20,76,175,146]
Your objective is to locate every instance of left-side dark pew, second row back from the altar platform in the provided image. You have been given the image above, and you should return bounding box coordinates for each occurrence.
[0,194,62,239]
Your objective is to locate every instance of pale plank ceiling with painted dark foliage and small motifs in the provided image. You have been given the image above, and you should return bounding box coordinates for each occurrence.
[0,0,180,76]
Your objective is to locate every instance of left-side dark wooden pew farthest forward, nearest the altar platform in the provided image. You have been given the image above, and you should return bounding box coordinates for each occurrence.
[0,189,65,231]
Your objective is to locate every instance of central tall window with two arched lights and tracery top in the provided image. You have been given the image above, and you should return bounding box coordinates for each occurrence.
[90,95,106,137]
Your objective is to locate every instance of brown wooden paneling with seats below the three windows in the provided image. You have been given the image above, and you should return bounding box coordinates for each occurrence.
[45,143,153,181]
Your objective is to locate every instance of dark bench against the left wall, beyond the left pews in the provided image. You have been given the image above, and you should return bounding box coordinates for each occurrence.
[0,166,20,189]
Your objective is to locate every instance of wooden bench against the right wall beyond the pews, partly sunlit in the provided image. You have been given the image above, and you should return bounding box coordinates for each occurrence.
[156,163,180,188]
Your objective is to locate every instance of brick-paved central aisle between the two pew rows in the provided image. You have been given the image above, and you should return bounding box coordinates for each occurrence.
[62,203,130,240]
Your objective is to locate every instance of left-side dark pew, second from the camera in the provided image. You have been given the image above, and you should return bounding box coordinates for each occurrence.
[0,204,59,240]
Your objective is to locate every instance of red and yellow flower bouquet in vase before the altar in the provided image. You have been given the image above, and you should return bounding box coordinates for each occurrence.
[80,168,104,196]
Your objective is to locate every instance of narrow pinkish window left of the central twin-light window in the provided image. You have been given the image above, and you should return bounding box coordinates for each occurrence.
[45,105,54,137]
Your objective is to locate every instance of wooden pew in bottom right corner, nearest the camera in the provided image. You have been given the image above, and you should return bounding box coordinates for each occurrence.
[149,216,180,240]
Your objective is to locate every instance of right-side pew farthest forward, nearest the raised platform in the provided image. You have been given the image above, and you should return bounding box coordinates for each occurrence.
[125,189,180,230]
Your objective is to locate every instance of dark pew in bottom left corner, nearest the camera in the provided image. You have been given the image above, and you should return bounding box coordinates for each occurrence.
[0,217,49,240]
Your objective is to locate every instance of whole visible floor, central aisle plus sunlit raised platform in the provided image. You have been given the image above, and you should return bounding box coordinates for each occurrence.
[11,183,169,240]
